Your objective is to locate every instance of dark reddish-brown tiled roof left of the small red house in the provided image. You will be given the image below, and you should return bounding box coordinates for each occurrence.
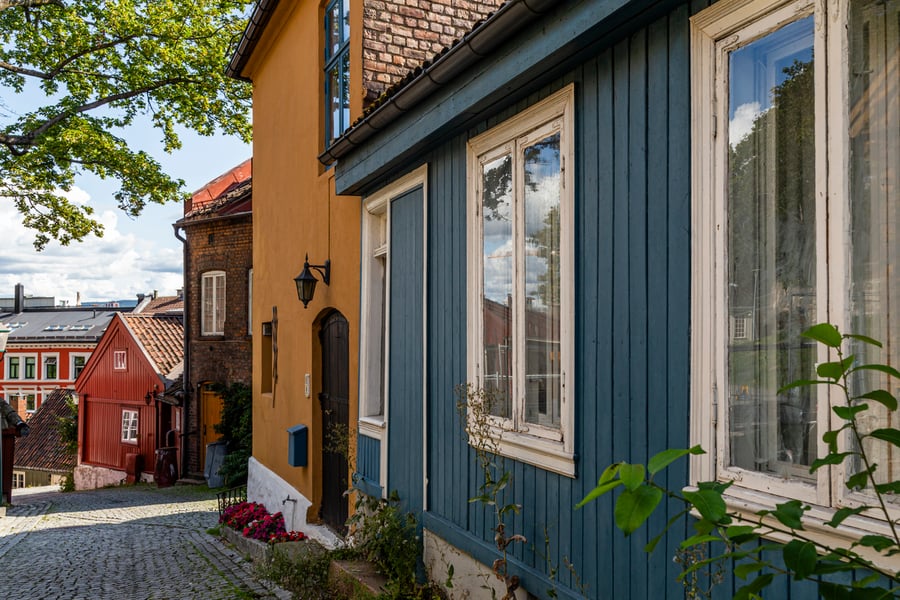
[13,389,75,473]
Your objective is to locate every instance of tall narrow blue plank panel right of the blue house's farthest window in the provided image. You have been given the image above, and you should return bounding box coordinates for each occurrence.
[387,188,425,512]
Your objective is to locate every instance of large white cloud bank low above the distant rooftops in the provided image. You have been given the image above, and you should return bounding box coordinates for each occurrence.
[0,187,182,304]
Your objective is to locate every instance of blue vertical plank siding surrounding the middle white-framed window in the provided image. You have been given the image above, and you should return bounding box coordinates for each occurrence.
[422,6,690,598]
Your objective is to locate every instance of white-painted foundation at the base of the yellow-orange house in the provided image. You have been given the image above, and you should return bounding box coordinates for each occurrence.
[247,456,344,548]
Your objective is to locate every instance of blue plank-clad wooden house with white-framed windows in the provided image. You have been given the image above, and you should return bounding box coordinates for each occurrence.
[320,0,900,598]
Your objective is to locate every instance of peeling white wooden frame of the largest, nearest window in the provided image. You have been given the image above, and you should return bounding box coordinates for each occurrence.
[691,0,898,548]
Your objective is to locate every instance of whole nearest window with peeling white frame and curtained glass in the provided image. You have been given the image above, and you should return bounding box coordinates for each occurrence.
[691,0,900,524]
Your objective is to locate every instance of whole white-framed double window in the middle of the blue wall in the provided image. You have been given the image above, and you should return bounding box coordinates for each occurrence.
[467,86,574,476]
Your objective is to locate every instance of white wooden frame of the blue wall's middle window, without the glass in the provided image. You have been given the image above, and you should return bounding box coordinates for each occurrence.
[466,85,575,477]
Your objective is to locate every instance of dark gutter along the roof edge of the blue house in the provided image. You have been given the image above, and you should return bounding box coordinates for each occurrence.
[319,0,559,165]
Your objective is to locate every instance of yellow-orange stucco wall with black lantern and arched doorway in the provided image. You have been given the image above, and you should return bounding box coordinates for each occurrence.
[243,1,362,518]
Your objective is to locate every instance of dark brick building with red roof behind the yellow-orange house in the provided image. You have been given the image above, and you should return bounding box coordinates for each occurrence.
[174,159,253,476]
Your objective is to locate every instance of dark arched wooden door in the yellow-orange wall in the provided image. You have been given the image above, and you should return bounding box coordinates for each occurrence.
[319,311,350,532]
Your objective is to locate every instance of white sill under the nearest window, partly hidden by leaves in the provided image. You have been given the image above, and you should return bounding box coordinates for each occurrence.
[723,485,900,572]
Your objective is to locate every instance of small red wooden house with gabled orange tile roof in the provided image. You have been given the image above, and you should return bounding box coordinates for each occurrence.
[75,312,184,489]
